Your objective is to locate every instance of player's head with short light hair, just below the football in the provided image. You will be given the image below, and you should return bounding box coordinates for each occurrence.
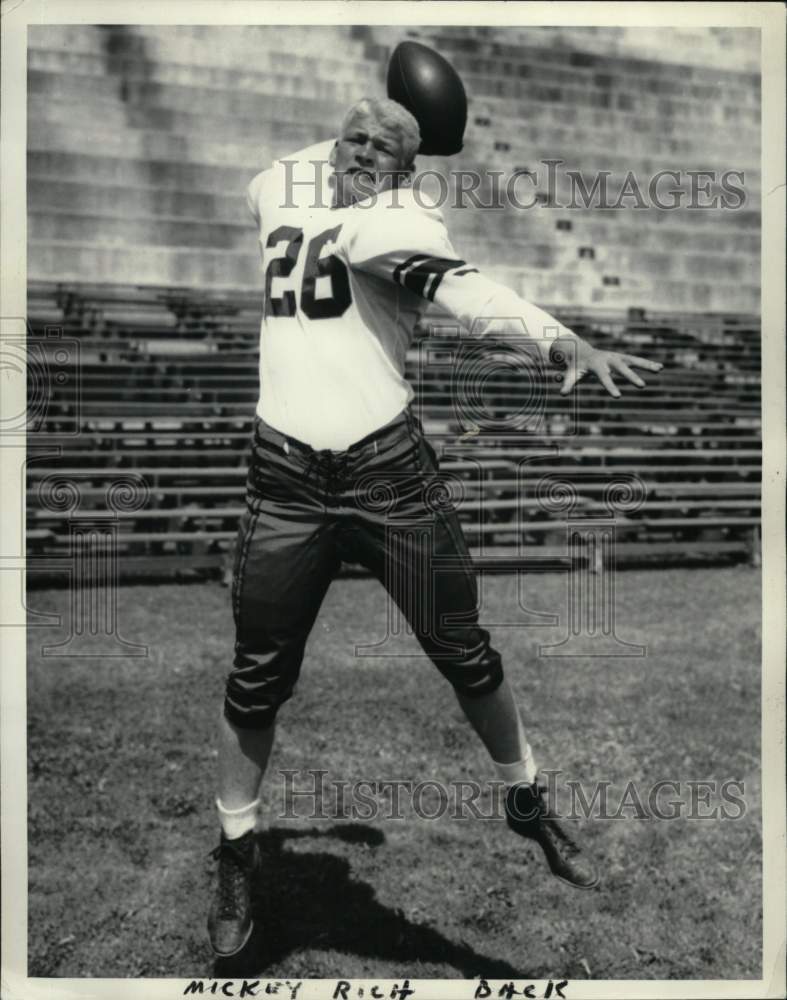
[333,111,410,206]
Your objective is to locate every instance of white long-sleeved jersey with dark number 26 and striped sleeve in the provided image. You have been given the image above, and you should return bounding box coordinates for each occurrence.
[248,143,556,450]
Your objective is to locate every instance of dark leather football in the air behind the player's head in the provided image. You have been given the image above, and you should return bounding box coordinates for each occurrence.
[387,42,467,156]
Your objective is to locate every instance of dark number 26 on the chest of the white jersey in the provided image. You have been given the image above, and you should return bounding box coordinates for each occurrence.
[265,226,352,319]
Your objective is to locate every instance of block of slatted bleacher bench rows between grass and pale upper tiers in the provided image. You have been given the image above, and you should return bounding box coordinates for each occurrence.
[28,282,761,569]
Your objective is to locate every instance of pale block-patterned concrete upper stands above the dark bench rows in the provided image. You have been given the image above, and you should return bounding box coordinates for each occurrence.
[28,25,760,312]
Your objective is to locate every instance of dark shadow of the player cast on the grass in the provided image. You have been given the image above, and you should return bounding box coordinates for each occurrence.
[213,823,527,979]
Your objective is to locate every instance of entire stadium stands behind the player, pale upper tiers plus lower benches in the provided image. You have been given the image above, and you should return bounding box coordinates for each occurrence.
[27,25,760,573]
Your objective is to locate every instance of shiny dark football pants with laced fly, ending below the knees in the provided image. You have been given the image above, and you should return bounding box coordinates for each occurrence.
[224,410,503,728]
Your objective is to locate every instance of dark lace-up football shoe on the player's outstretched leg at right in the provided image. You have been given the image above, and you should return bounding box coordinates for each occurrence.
[506,783,600,889]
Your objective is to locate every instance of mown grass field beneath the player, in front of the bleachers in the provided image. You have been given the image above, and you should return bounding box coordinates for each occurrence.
[28,567,762,979]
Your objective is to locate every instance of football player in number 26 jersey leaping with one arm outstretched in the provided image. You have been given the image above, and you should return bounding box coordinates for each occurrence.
[208,99,661,955]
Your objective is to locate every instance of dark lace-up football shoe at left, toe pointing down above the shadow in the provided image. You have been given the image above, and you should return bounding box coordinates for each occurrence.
[208,830,259,958]
